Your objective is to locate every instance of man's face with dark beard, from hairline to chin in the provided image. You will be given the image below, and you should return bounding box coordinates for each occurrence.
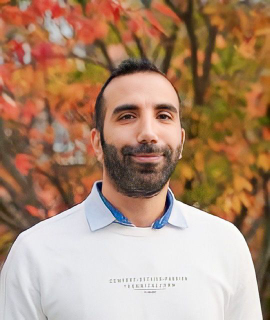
[92,72,184,198]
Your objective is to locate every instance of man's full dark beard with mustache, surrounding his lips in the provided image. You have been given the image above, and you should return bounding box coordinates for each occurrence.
[102,139,181,198]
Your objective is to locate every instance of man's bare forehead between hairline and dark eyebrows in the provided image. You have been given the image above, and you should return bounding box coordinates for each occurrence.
[104,72,179,111]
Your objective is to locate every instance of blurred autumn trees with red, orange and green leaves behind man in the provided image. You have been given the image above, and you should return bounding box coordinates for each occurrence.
[0,0,270,320]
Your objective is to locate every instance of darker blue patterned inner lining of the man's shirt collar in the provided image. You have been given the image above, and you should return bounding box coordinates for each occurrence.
[96,181,173,229]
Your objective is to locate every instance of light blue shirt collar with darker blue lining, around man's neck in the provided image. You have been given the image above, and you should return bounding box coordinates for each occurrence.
[85,181,188,231]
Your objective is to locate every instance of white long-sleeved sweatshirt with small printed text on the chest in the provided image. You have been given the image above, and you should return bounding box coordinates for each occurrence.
[0,182,262,320]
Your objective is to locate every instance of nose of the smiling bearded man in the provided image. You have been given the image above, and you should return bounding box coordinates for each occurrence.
[137,117,158,144]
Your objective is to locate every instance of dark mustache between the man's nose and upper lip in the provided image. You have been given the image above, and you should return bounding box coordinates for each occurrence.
[121,144,172,157]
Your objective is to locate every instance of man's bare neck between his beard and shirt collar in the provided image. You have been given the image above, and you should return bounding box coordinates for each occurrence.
[102,176,169,227]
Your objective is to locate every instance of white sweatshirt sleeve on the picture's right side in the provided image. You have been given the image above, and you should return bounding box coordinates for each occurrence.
[225,227,263,320]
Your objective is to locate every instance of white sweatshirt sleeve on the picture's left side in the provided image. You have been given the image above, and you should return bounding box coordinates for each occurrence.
[0,235,47,320]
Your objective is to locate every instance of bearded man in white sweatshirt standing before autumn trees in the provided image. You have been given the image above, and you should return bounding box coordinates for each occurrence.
[0,59,262,320]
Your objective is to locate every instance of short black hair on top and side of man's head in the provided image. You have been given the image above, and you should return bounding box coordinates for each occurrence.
[94,58,181,137]
